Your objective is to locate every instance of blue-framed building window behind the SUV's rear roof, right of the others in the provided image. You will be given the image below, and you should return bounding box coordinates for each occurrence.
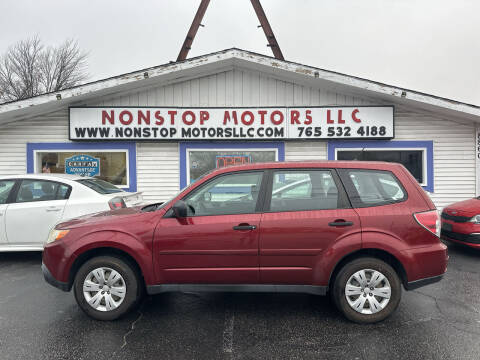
[328,141,433,192]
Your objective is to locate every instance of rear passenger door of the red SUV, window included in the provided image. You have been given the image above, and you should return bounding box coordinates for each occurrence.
[259,169,361,285]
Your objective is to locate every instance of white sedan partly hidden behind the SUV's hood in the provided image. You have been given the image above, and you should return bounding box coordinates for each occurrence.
[0,174,143,251]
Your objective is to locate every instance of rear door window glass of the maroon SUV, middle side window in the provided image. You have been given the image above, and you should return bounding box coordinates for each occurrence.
[270,170,343,212]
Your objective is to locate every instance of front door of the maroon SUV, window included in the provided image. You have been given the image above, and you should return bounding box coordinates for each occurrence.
[154,171,265,284]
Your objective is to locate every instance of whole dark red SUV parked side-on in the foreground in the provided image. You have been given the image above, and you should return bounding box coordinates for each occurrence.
[42,161,448,323]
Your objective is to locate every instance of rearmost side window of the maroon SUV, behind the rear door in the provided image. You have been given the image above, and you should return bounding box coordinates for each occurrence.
[341,169,407,207]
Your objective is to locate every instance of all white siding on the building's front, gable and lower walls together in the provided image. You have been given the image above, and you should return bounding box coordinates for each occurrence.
[0,68,476,207]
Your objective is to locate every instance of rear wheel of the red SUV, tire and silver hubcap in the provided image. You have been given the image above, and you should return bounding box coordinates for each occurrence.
[332,257,402,324]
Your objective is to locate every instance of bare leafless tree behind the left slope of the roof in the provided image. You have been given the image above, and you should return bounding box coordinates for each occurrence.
[0,36,88,102]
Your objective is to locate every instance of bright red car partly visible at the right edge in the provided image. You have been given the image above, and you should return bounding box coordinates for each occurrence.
[442,198,480,249]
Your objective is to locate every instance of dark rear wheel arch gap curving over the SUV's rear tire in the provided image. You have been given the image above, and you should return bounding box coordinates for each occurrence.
[328,248,408,290]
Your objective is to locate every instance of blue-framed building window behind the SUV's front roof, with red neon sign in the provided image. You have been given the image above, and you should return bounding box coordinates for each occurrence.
[180,142,285,188]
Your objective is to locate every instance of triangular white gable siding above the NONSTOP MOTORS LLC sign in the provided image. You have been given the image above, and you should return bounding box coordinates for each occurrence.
[90,69,378,106]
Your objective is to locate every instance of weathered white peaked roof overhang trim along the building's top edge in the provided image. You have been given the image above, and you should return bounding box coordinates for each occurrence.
[0,48,480,124]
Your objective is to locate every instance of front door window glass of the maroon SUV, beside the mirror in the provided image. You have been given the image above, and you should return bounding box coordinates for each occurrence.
[183,172,263,216]
